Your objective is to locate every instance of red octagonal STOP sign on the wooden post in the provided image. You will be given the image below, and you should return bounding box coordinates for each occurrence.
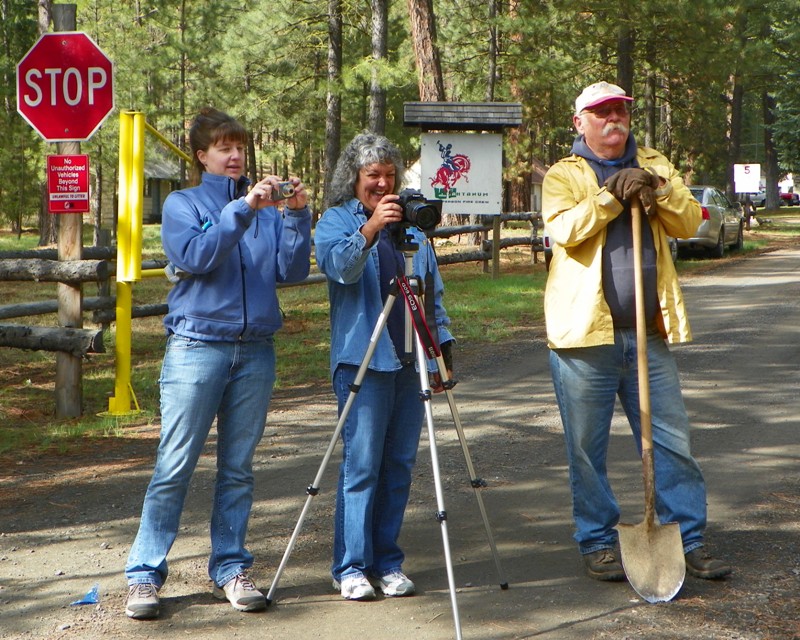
[17,31,114,142]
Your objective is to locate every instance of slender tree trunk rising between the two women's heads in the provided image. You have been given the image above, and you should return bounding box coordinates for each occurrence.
[323,0,342,209]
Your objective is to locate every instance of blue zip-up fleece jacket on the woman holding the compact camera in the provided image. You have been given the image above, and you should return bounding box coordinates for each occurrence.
[161,173,311,342]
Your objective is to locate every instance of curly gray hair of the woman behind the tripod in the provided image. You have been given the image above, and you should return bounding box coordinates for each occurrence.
[328,131,405,206]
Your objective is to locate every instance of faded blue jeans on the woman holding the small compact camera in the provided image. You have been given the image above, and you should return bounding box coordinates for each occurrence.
[125,335,275,588]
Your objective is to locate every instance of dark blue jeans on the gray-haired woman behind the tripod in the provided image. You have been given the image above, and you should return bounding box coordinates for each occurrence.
[331,364,425,581]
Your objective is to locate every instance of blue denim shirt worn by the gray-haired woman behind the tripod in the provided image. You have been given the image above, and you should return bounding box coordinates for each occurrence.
[314,198,453,375]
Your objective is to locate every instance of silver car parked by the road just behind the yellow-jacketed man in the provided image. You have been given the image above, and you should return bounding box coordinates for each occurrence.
[678,185,744,258]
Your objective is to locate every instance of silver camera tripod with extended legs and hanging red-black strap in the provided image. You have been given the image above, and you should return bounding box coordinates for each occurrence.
[267,236,508,640]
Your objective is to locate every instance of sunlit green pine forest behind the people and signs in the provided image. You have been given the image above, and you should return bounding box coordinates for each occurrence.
[0,0,800,244]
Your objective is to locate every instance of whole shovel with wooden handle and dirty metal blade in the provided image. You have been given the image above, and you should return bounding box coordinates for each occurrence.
[617,196,686,602]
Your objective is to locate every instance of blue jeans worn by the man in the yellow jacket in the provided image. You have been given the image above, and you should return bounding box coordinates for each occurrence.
[550,329,706,554]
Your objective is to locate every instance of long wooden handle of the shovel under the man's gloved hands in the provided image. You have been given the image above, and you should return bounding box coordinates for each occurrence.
[631,195,656,522]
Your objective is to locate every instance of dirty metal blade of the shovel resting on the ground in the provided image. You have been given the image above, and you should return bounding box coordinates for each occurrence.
[617,521,686,602]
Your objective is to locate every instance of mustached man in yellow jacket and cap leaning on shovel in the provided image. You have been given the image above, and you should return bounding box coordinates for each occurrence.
[543,82,731,580]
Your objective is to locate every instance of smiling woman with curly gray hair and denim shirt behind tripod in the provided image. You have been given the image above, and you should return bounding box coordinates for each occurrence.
[314,133,453,600]
